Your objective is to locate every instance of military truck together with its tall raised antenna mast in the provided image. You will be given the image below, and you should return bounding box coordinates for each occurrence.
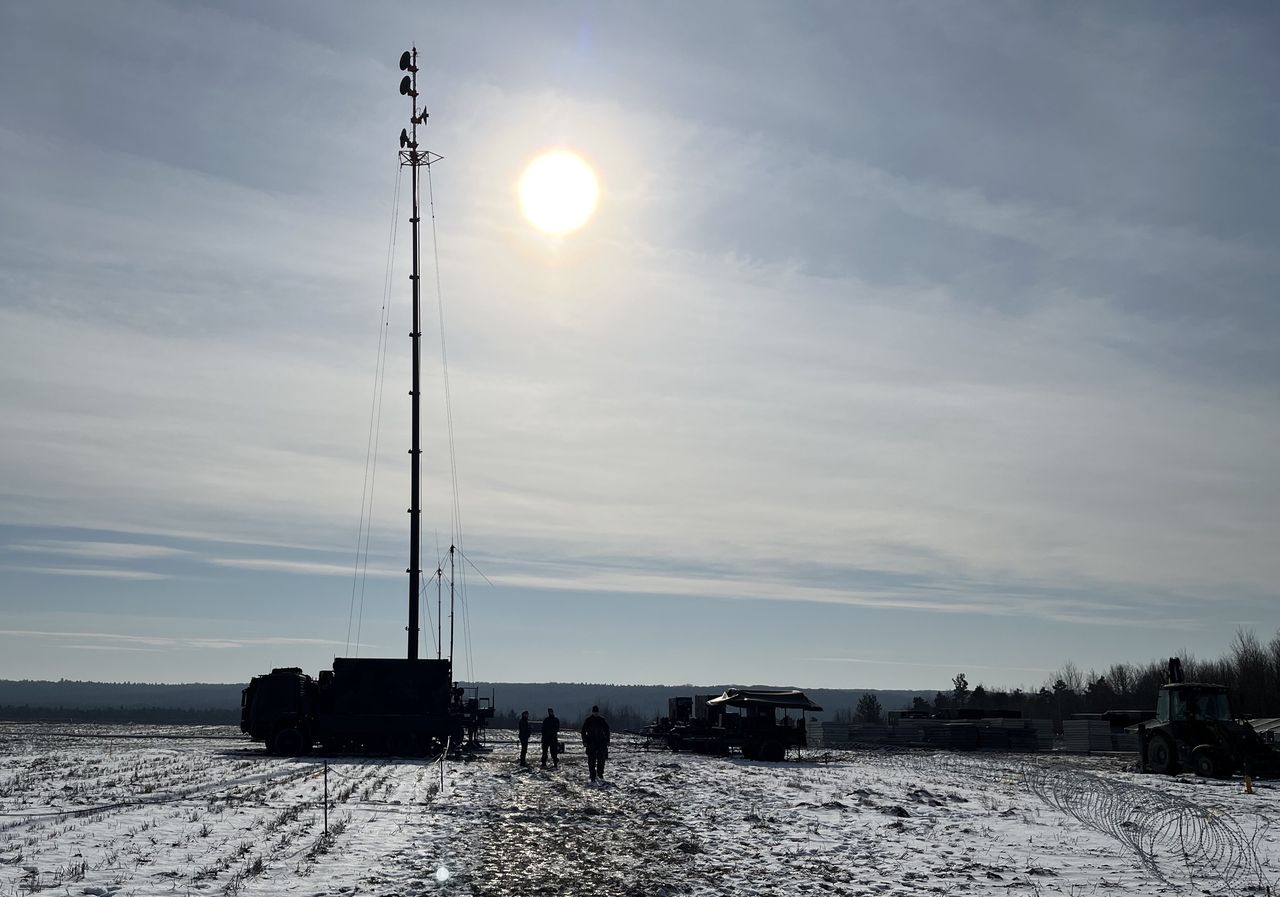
[241,49,483,755]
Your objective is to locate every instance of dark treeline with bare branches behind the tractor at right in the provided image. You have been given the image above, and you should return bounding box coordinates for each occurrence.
[875,630,1280,728]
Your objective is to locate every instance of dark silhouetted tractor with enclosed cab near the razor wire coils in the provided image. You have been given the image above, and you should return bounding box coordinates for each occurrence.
[1138,658,1280,778]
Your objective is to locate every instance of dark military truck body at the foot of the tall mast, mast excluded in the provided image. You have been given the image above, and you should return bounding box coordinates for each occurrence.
[241,658,493,756]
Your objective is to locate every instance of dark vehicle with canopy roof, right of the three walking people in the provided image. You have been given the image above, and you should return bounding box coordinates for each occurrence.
[643,688,822,763]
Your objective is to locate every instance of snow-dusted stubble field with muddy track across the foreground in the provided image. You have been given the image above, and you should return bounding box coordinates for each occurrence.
[0,723,1280,897]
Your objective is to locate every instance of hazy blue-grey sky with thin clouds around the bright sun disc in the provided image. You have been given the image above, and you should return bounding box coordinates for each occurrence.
[0,0,1280,688]
